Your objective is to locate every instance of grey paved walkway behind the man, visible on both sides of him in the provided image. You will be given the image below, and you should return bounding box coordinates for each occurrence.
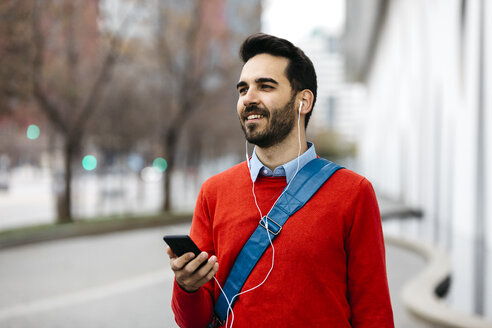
[0,223,440,328]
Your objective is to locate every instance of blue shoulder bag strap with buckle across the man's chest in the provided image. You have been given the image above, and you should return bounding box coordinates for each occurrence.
[211,158,342,327]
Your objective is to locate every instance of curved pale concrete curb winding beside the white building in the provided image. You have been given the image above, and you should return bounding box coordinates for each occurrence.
[384,234,492,328]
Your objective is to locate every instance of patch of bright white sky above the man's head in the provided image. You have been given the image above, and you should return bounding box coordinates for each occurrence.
[262,0,345,43]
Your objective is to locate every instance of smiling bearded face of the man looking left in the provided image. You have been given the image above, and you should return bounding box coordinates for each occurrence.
[237,54,296,148]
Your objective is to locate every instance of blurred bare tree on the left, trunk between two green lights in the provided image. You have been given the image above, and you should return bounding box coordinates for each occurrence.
[32,0,119,223]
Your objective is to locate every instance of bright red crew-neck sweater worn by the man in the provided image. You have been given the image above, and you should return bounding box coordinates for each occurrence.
[172,162,394,328]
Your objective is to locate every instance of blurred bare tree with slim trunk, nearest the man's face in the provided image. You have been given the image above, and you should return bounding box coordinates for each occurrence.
[155,0,261,211]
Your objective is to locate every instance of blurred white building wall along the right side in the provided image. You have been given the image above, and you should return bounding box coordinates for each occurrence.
[345,0,492,318]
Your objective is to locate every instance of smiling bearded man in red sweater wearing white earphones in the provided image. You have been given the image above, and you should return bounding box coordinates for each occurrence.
[168,34,393,328]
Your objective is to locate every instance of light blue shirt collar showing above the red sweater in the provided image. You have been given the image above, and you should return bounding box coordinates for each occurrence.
[249,142,317,182]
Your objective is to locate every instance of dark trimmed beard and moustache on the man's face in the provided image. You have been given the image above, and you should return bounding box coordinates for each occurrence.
[241,95,296,148]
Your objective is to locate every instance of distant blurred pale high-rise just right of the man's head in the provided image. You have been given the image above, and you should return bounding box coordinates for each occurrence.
[296,28,365,169]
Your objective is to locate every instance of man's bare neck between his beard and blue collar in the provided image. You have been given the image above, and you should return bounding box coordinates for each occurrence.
[256,133,307,170]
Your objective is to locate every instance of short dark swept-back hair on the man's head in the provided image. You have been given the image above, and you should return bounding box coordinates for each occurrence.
[239,33,318,127]
